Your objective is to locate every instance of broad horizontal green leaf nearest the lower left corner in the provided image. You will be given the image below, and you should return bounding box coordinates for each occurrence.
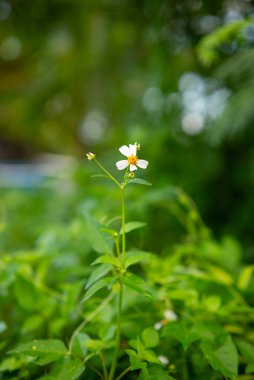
[11,339,67,365]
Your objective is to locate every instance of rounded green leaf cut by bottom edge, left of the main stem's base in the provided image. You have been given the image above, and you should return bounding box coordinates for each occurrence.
[52,357,85,380]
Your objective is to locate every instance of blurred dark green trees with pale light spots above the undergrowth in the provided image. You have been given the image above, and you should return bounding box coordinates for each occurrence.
[0,0,254,249]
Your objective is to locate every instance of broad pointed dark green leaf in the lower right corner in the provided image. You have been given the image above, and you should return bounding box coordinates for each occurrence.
[200,334,238,379]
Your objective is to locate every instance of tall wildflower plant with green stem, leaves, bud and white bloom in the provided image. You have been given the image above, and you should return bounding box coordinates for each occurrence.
[83,143,151,380]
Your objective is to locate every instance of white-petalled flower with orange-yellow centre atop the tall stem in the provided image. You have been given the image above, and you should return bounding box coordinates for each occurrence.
[116,144,148,172]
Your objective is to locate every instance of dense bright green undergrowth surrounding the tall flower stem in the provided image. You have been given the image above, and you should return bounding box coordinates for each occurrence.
[0,184,254,380]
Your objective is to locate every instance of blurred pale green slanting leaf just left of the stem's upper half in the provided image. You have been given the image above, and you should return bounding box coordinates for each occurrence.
[84,213,113,254]
